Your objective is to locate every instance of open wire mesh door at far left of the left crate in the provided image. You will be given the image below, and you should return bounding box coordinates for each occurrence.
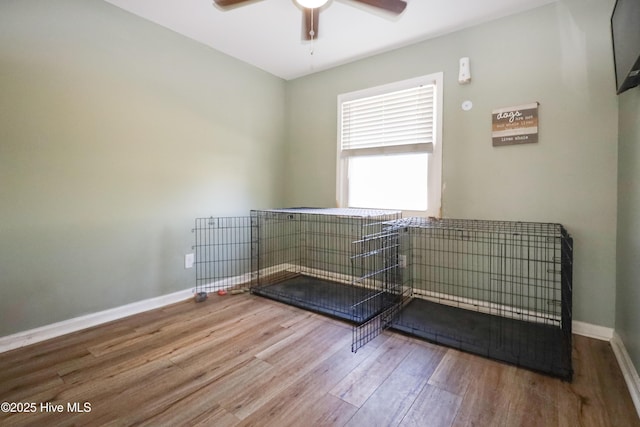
[193,217,253,293]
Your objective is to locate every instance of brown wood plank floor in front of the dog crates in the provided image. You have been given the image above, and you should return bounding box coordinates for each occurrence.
[0,295,640,427]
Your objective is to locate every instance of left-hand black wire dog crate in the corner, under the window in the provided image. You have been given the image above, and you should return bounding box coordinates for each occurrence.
[251,208,401,324]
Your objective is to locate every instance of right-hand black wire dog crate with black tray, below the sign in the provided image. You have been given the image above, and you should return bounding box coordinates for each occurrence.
[390,218,573,379]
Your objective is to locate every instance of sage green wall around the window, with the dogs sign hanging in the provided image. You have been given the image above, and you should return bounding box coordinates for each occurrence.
[286,0,618,327]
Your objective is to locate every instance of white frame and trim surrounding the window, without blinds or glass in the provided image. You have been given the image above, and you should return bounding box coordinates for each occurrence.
[336,72,444,218]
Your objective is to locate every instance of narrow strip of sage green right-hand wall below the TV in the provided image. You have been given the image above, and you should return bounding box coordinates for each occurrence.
[616,87,640,370]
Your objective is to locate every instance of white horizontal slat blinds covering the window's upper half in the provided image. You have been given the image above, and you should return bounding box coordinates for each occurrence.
[340,84,435,156]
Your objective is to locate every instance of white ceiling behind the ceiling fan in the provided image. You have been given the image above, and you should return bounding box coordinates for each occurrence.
[106,0,556,80]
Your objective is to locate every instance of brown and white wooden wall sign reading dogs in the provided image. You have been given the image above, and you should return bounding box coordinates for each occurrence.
[491,102,539,147]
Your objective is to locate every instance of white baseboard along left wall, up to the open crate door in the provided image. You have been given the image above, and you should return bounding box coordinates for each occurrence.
[0,289,193,353]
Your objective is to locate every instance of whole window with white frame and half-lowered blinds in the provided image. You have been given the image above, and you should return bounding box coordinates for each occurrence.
[337,73,443,216]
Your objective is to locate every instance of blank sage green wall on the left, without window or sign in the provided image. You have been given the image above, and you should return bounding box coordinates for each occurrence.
[0,0,285,336]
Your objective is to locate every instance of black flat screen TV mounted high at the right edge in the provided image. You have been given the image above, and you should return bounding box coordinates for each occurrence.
[611,0,640,94]
